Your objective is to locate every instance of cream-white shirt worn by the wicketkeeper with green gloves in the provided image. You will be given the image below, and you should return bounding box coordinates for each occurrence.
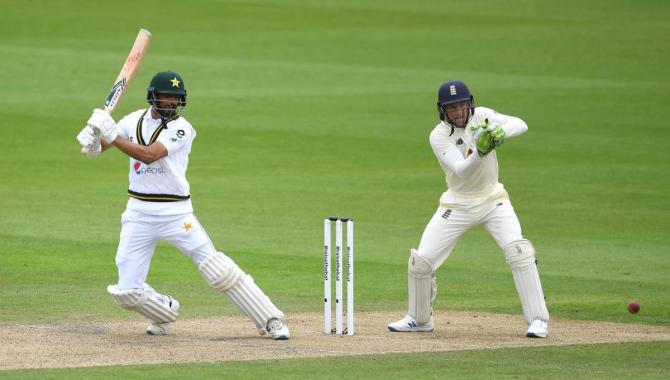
[430,107,528,208]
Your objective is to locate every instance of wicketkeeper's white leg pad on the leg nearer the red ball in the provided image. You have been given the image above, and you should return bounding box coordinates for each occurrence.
[503,239,549,324]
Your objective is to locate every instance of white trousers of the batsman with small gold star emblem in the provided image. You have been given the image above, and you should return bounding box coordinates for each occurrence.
[116,210,216,290]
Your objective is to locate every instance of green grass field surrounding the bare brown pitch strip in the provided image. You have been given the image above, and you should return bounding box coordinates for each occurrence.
[0,0,670,378]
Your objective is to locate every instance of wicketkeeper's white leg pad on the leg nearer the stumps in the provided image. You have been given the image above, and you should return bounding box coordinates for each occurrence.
[407,249,437,325]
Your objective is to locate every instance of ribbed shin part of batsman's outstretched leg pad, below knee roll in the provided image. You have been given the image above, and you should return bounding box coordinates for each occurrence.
[224,275,284,335]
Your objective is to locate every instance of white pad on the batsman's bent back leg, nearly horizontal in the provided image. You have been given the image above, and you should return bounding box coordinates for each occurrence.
[107,285,179,323]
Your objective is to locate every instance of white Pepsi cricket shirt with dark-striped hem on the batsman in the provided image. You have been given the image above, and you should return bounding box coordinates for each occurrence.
[116,108,196,215]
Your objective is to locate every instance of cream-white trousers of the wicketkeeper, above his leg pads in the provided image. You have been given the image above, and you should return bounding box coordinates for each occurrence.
[418,197,523,270]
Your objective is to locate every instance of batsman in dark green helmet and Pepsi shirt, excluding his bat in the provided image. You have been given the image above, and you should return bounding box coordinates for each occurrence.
[77,71,289,340]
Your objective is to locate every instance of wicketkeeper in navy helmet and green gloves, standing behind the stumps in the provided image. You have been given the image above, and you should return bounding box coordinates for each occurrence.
[388,80,549,338]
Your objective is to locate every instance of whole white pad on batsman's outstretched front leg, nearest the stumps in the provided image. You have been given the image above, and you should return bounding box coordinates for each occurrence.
[198,252,284,335]
